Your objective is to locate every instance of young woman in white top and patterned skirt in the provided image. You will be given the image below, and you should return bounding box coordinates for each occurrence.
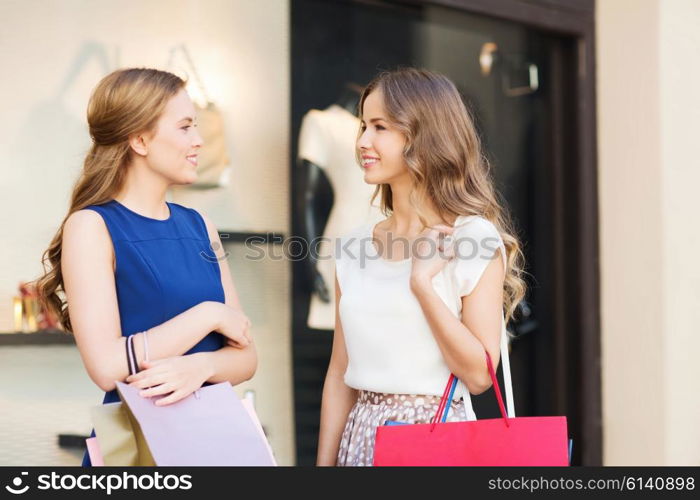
[317,68,525,466]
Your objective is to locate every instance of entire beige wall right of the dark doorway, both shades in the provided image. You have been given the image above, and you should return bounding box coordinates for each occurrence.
[596,0,700,465]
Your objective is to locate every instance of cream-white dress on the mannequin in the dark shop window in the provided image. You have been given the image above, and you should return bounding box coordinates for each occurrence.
[299,104,382,330]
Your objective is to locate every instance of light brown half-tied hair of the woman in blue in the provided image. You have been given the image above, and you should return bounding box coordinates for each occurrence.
[35,68,186,331]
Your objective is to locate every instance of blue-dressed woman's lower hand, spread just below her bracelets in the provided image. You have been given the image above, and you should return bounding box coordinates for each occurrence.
[126,353,212,406]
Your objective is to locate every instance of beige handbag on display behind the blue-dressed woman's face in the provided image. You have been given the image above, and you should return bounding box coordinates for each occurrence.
[167,44,230,189]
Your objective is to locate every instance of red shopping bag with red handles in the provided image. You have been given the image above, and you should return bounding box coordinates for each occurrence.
[374,353,569,466]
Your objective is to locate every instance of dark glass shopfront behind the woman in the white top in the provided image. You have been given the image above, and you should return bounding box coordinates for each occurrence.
[291,0,579,465]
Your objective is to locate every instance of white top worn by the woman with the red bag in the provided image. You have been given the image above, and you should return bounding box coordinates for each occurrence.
[335,215,514,420]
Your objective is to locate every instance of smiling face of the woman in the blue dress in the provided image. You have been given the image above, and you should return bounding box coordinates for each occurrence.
[132,89,203,184]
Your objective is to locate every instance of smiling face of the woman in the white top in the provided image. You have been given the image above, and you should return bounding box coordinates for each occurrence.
[357,89,410,184]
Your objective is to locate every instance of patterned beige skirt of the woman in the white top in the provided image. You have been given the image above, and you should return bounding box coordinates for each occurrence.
[337,391,467,467]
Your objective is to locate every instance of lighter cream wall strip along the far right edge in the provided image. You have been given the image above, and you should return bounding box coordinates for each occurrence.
[660,0,700,465]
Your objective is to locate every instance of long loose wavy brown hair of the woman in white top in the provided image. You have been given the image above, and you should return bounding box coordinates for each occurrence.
[357,68,526,322]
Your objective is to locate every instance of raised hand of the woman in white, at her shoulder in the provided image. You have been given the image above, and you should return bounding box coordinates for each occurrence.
[411,224,454,290]
